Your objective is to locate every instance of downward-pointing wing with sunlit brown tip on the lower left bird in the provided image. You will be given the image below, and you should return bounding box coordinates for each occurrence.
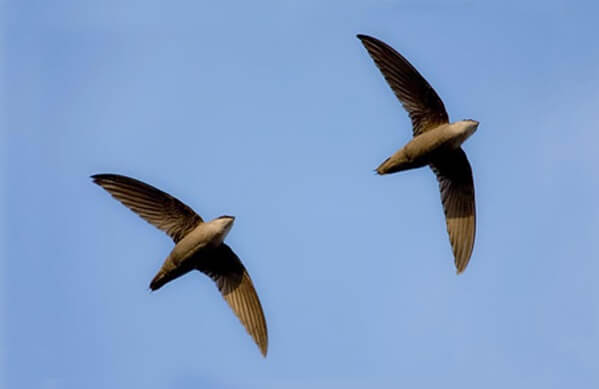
[196,243,268,356]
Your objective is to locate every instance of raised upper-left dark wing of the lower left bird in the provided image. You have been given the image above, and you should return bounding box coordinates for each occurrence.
[91,174,203,243]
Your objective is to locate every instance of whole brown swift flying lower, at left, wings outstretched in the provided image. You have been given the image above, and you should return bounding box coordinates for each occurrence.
[91,174,268,357]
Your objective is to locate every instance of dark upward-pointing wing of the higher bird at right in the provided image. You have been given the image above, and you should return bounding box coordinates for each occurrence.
[358,35,449,136]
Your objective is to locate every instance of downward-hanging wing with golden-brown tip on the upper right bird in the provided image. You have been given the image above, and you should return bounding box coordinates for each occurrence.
[430,148,476,274]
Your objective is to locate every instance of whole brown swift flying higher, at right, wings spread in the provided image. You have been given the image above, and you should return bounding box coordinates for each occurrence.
[357,35,478,274]
